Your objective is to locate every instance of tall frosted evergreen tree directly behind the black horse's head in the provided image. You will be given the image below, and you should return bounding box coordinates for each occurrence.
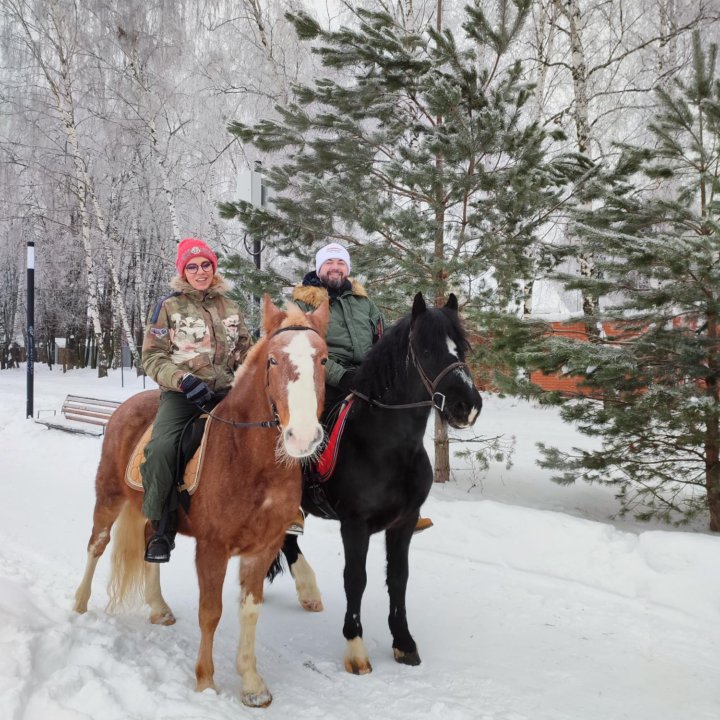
[221,0,565,480]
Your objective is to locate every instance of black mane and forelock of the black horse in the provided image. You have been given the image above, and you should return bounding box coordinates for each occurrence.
[355,308,470,400]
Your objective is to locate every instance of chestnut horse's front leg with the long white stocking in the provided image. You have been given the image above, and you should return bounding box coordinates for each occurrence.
[237,553,275,707]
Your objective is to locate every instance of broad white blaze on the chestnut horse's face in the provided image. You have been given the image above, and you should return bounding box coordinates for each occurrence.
[283,331,323,457]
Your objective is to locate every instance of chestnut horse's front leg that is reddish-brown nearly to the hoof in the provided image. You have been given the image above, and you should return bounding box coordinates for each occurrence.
[195,540,228,692]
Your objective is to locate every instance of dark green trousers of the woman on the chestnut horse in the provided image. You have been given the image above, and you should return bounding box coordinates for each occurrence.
[140,390,200,522]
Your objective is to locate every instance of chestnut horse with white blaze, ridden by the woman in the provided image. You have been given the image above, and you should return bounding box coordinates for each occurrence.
[74,296,329,707]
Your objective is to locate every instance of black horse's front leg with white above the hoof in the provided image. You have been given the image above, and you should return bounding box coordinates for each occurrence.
[340,520,372,675]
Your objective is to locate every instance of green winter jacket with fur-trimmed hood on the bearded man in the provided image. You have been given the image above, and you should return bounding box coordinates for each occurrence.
[292,272,383,387]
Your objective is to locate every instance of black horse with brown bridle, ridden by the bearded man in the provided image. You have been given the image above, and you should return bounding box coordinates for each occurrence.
[276,293,482,674]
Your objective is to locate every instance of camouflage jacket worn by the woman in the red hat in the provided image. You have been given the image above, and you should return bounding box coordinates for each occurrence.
[142,275,252,391]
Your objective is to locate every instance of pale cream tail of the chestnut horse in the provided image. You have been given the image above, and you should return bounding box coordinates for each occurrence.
[107,502,146,612]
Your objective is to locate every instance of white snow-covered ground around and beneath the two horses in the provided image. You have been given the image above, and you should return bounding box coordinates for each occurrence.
[0,365,720,720]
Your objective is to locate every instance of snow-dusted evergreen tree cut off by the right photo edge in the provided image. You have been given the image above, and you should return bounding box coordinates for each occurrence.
[524,35,720,531]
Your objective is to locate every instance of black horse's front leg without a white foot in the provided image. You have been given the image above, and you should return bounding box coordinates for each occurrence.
[385,518,420,665]
